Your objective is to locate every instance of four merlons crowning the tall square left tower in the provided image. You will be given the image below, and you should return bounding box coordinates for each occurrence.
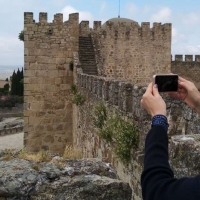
[24,12,79,24]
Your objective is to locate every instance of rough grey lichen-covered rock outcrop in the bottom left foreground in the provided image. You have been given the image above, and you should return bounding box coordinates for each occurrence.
[0,152,132,200]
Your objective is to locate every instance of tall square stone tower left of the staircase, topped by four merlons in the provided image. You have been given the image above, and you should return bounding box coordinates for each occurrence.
[24,13,79,153]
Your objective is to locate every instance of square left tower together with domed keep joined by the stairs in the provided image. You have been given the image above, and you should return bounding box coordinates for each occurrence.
[24,13,171,153]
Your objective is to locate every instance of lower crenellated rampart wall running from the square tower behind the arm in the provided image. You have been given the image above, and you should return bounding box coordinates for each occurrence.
[74,74,200,200]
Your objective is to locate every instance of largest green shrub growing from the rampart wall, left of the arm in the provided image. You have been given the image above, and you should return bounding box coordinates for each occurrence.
[94,104,139,162]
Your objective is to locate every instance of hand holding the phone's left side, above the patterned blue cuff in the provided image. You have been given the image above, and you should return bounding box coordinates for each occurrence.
[141,83,166,117]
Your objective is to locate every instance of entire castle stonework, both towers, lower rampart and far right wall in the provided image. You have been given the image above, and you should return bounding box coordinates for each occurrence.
[24,13,200,200]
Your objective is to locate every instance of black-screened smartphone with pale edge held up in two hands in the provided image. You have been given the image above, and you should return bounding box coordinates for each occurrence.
[153,74,178,92]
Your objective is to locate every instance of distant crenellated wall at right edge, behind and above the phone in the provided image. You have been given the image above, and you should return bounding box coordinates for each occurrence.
[171,55,200,90]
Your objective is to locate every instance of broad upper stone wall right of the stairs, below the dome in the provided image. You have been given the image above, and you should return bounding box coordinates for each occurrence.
[92,21,171,85]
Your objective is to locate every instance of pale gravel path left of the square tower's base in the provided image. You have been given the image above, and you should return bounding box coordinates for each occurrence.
[0,132,24,150]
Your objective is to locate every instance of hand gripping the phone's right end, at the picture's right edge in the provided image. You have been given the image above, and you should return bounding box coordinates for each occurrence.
[168,76,200,114]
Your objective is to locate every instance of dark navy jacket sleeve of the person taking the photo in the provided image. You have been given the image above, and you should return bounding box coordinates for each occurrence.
[141,126,200,200]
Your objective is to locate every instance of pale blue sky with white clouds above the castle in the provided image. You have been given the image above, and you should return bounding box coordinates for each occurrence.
[0,0,200,66]
